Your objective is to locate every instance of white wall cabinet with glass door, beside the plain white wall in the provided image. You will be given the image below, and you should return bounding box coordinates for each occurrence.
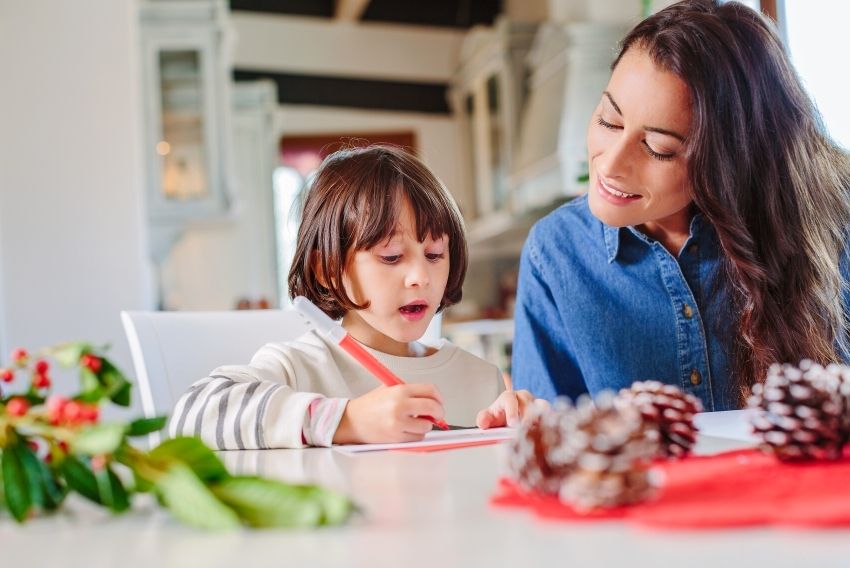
[139,0,231,239]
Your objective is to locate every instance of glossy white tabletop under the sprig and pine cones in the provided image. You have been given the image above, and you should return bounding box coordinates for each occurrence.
[0,437,850,568]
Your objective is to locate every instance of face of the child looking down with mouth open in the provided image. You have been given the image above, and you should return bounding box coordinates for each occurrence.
[342,197,450,355]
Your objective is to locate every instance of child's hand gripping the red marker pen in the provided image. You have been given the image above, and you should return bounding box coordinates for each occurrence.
[333,384,445,444]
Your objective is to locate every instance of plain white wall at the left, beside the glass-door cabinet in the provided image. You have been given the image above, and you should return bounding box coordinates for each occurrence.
[0,0,152,410]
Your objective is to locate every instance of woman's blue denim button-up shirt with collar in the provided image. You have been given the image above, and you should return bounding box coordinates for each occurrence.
[512,196,739,411]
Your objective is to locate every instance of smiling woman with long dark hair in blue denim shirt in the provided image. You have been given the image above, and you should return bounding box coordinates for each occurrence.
[513,0,850,410]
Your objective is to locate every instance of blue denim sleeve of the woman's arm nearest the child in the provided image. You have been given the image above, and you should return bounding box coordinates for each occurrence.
[511,224,587,400]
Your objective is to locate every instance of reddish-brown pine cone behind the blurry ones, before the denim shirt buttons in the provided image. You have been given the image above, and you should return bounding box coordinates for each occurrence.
[616,381,702,458]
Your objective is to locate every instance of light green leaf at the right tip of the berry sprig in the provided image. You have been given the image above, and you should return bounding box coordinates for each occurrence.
[213,477,353,528]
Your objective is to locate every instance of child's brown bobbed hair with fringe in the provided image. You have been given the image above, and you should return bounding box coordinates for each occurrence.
[289,145,468,319]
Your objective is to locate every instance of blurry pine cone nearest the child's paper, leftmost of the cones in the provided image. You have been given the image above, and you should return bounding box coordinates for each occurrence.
[508,399,573,495]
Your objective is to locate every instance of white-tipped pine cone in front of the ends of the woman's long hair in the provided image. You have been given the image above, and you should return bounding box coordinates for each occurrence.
[748,360,846,461]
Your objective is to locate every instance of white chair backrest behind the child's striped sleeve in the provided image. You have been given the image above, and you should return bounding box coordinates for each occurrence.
[121,310,308,417]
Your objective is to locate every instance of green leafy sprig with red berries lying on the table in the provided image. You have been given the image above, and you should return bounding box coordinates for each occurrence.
[0,343,353,529]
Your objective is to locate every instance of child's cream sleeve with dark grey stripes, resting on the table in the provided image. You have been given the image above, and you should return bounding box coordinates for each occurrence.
[169,346,336,450]
